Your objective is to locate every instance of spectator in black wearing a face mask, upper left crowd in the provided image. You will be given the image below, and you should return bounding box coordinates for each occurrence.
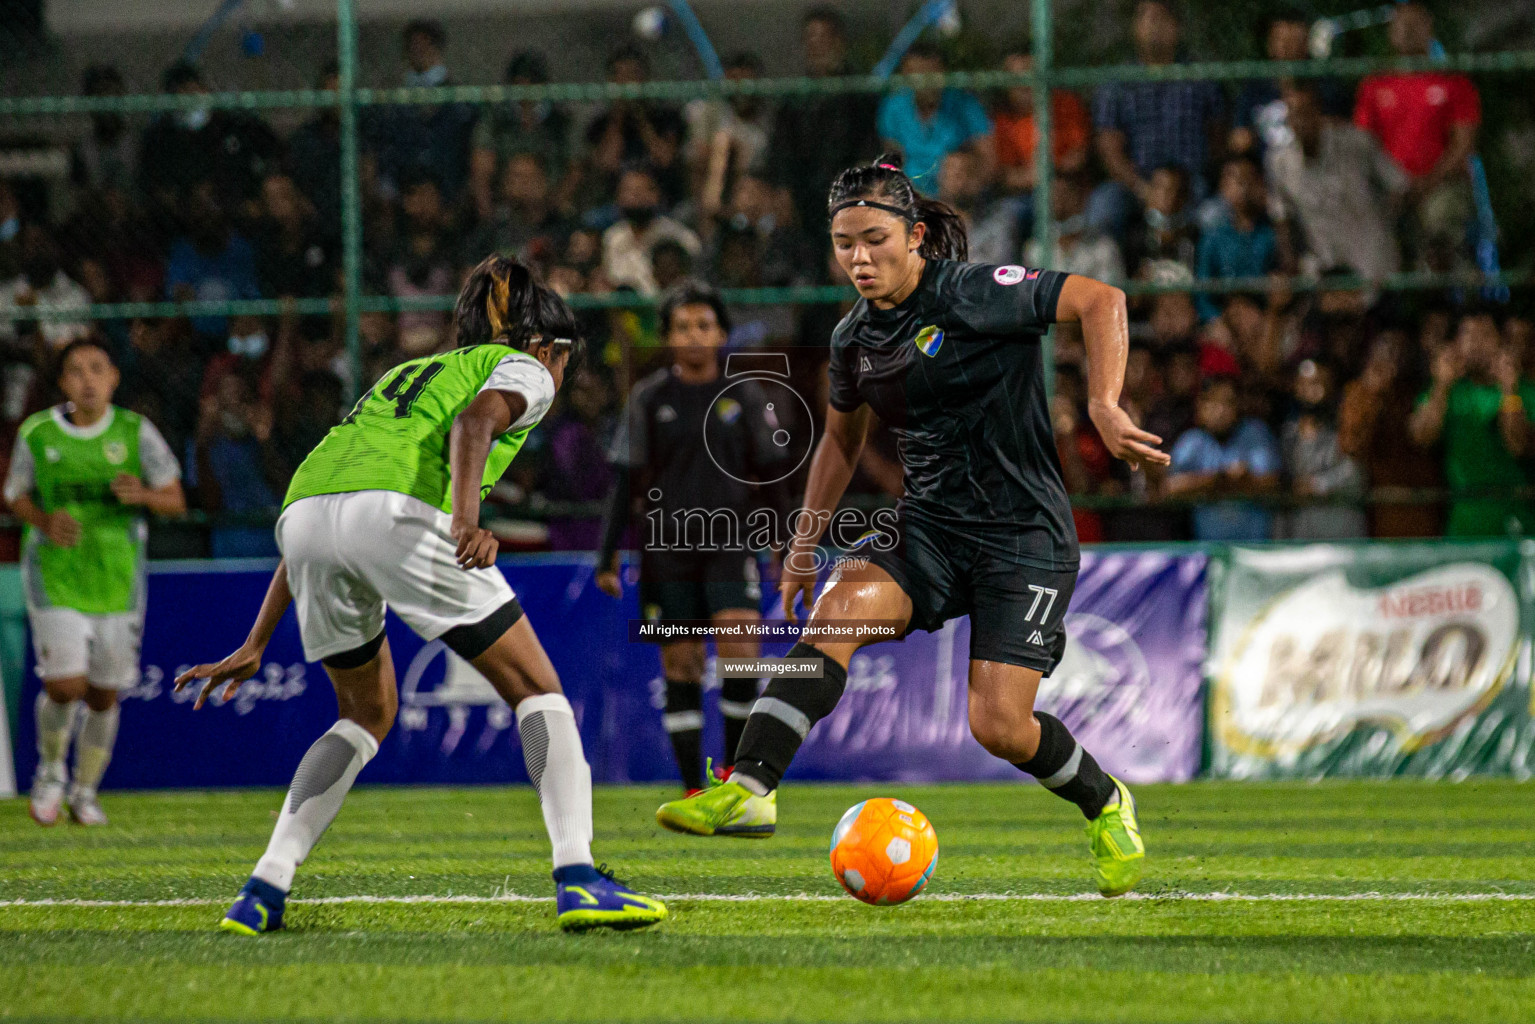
[138,61,282,227]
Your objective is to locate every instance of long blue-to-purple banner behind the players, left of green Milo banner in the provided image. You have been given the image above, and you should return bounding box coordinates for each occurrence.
[15,551,1205,788]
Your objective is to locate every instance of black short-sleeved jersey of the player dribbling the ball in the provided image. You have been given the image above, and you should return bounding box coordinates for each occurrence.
[829,259,1078,570]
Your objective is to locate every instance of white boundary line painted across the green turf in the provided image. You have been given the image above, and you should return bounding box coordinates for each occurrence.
[0,892,1535,909]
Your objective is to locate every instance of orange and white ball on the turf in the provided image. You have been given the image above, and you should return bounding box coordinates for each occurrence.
[832,797,938,906]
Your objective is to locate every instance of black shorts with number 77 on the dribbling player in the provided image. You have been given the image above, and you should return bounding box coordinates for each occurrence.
[849,519,1076,676]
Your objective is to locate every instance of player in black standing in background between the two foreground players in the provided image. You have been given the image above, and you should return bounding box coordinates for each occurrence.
[597,281,787,794]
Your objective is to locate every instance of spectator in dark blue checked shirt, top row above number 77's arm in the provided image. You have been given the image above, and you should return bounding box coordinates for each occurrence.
[1088,0,1225,239]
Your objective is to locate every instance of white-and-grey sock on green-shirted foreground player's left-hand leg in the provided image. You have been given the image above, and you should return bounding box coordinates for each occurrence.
[250,718,379,892]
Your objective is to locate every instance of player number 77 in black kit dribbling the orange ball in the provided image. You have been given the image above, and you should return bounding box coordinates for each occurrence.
[657,161,1168,897]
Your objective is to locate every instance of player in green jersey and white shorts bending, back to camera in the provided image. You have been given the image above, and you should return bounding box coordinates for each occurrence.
[177,256,666,935]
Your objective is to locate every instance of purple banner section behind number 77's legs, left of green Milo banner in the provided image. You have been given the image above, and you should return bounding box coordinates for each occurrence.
[789,551,1207,783]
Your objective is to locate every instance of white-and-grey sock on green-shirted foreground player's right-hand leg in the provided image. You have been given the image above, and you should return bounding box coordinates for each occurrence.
[517,694,591,870]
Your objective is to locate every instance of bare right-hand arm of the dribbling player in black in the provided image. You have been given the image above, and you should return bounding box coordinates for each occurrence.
[1056,273,1171,470]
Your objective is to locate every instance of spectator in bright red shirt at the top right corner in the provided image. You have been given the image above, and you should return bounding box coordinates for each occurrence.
[1354,0,1481,269]
